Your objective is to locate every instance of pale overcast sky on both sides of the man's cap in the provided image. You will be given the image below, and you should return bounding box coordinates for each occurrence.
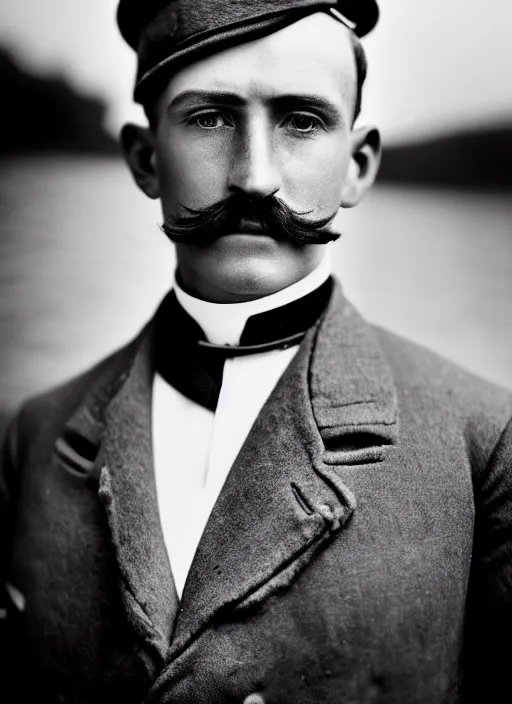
[0,0,512,142]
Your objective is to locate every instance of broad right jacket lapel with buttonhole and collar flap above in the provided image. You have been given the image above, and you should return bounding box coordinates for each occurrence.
[170,280,397,660]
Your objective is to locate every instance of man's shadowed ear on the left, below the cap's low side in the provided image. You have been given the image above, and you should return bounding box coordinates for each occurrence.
[121,124,160,198]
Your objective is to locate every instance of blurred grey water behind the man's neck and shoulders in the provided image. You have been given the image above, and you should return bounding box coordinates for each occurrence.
[0,157,512,418]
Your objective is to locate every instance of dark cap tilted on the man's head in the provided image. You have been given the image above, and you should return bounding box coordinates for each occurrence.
[117,0,379,103]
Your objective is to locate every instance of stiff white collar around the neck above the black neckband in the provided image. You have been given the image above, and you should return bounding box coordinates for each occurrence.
[173,252,331,345]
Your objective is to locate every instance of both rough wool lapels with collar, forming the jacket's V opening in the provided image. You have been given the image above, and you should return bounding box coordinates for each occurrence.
[54,280,398,676]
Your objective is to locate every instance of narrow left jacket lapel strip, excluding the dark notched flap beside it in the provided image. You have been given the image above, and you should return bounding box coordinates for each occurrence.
[99,335,178,660]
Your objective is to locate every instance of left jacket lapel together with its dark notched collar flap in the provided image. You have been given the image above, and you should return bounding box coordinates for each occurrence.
[56,324,178,672]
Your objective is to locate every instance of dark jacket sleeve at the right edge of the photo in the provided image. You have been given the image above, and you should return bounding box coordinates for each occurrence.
[464,421,512,704]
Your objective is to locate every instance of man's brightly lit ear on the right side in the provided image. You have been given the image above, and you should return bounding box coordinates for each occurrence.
[341,127,382,208]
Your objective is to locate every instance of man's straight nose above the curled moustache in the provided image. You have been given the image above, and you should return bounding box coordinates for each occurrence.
[228,119,281,198]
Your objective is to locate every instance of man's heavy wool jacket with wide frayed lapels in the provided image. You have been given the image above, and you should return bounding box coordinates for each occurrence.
[0,290,512,704]
